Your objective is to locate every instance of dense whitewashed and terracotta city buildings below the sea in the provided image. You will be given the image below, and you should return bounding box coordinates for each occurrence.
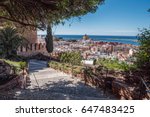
[38,35,138,63]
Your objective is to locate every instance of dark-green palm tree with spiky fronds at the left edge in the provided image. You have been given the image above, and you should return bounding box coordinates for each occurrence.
[0,27,27,58]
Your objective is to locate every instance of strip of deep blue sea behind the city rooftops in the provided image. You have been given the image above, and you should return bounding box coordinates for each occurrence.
[55,35,139,46]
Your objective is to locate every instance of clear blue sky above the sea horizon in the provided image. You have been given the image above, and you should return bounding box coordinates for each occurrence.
[38,0,150,35]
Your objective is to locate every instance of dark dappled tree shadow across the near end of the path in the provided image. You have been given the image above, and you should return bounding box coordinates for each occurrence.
[12,80,115,100]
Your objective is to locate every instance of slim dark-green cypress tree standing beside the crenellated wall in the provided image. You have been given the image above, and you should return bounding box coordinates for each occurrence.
[45,24,53,53]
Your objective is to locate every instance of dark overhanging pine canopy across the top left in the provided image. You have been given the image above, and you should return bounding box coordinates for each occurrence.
[0,0,104,29]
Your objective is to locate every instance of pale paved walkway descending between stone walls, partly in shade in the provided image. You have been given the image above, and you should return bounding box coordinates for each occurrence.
[12,60,115,100]
